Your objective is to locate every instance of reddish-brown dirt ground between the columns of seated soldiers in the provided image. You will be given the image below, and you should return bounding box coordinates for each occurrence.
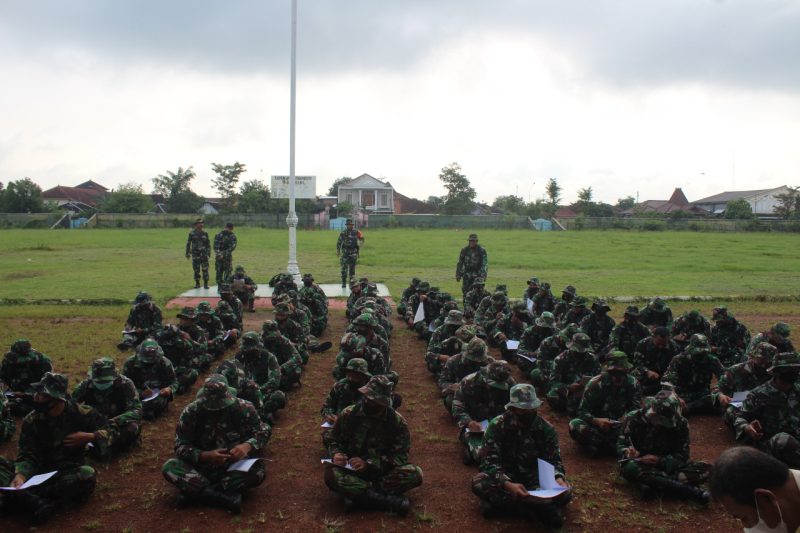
[0,309,786,532]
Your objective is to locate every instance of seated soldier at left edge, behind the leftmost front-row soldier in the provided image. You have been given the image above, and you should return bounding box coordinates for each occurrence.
[0,339,53,416]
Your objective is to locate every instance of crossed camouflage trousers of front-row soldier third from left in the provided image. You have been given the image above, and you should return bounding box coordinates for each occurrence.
[325,464,422,496]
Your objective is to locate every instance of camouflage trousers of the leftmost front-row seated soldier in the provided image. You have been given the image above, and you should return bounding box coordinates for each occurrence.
[0,457,97,502]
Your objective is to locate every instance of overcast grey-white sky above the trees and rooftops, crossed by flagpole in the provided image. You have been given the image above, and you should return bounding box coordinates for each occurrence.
[0,0,800,203]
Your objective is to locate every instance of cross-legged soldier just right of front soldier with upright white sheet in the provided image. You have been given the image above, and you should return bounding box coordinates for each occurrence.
[617,390,711,505]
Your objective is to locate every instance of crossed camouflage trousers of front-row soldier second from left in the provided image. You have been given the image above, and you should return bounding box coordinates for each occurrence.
[161,459,267,496]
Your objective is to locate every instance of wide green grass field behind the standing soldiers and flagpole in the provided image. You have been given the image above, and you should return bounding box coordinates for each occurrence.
[0,228,800,301]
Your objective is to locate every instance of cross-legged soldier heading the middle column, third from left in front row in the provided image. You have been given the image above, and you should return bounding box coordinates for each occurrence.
[325,376,422,515]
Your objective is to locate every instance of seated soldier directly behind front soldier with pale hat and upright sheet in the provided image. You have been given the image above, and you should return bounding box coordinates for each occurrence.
[450,361,515,465]
